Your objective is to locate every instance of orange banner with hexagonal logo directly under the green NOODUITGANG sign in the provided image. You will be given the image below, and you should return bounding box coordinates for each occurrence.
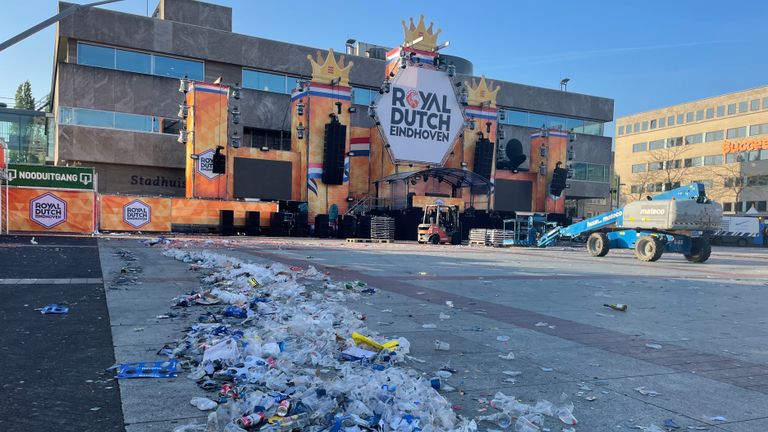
[8,187,94,234]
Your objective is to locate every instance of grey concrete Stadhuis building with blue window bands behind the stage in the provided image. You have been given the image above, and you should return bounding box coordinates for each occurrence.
[52,0,613,216]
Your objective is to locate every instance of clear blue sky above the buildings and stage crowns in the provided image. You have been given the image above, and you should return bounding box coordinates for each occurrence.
[0,0,768,135]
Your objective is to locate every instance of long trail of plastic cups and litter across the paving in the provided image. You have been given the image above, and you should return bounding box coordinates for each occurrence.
[164,249,576,432]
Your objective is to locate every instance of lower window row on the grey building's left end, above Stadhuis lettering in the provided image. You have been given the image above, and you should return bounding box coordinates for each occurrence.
[58,106,182,135]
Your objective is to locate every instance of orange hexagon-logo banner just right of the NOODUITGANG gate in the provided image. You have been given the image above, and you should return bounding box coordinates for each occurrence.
[99,195,171,232]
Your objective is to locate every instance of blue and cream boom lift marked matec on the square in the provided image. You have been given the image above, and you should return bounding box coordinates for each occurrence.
[537,183,723,263]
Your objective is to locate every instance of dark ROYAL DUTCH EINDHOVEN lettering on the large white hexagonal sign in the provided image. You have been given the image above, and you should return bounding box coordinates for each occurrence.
[389,87,451,142]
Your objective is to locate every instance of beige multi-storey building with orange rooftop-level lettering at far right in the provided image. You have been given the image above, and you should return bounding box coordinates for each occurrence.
[614,86,768,215]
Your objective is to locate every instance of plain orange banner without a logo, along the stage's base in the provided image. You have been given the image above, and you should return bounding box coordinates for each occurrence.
[171,198,278,227]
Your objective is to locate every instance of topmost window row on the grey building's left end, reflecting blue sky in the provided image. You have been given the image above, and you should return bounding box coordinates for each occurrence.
[77,42,205,81]
